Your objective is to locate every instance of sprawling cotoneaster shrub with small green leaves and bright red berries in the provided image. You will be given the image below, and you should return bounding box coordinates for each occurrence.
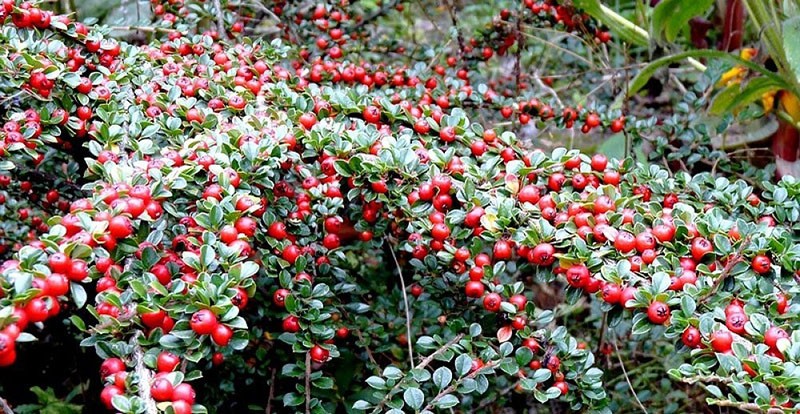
[0,0,800,413]
